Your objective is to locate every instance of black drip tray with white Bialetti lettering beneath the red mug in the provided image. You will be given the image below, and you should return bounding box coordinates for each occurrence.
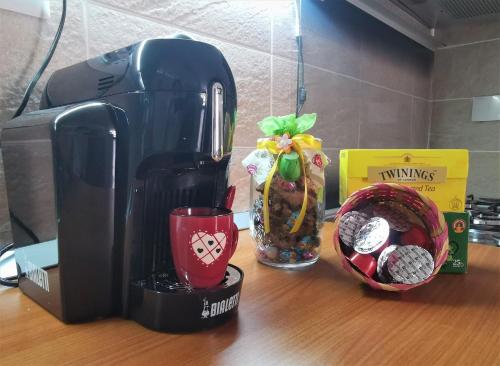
[130,264,243,333]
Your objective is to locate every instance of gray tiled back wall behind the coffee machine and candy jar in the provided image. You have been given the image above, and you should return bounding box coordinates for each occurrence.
[0,0,432,242]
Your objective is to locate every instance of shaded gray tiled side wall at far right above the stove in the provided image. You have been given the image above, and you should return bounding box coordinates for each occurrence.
[429,16,500,198]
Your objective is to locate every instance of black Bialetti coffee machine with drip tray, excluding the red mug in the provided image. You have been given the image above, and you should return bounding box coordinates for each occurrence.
[1,38,243,331]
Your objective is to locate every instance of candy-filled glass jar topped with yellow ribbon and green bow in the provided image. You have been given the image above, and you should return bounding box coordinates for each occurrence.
[243,114,329,268]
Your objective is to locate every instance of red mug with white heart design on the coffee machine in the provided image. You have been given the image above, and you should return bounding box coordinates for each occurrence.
[170,207,238,288]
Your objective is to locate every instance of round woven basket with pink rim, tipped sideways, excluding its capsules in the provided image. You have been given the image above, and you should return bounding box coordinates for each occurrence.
[333,183,448,291]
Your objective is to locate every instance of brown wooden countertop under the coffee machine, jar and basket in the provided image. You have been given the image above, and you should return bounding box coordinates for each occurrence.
[0,224,500,366]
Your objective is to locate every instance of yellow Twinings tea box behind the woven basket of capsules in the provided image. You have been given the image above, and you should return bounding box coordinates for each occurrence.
[339,149,469,212]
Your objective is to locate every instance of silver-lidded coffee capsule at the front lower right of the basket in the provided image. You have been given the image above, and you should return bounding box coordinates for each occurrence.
[387,245,434,285]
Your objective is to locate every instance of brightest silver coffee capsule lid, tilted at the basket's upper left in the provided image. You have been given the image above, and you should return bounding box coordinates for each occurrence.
[353,217,390,254]
